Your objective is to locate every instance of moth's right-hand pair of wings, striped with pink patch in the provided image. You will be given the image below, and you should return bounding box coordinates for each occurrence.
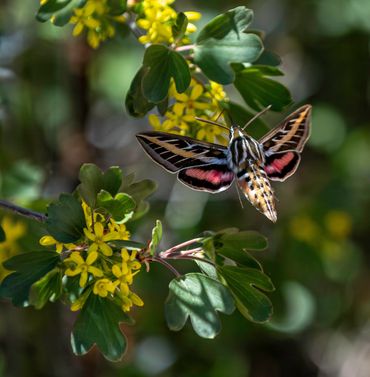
[260,105,312,181]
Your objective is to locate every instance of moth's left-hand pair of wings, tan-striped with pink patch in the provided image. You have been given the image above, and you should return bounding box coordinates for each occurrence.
[136,131,234,193]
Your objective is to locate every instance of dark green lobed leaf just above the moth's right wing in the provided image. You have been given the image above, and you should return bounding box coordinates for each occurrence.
[234,65,292,111]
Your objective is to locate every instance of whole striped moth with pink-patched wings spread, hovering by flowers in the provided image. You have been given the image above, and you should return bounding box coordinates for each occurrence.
[136,105,312,222]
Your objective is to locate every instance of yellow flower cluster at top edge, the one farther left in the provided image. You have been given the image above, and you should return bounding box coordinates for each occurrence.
[69,0,125,48]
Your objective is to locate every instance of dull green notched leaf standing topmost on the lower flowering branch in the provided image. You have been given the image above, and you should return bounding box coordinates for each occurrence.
[77,164,122,208]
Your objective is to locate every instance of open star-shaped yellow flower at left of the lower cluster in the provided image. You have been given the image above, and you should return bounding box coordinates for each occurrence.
[64,252,103,288]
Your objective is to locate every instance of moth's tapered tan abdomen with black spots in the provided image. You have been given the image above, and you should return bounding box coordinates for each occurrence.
[238,162,277,222]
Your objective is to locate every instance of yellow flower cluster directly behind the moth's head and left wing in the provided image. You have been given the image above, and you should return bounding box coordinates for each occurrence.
[149,79,227,144]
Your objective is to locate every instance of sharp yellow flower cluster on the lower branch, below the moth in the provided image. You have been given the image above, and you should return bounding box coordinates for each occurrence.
[40,202,144,312]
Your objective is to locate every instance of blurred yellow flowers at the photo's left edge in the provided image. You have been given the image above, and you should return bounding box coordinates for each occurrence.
[0,216,26,281]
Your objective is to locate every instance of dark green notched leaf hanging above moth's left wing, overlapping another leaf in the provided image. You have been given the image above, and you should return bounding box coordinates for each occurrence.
[142,44,191,103]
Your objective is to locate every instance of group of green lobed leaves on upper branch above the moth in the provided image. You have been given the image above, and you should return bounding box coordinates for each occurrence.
[126,6,292,118]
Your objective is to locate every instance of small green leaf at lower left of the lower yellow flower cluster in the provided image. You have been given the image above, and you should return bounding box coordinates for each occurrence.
[29,268,62,309]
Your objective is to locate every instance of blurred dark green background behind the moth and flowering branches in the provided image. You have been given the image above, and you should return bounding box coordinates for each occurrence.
[0,0,370,377]
